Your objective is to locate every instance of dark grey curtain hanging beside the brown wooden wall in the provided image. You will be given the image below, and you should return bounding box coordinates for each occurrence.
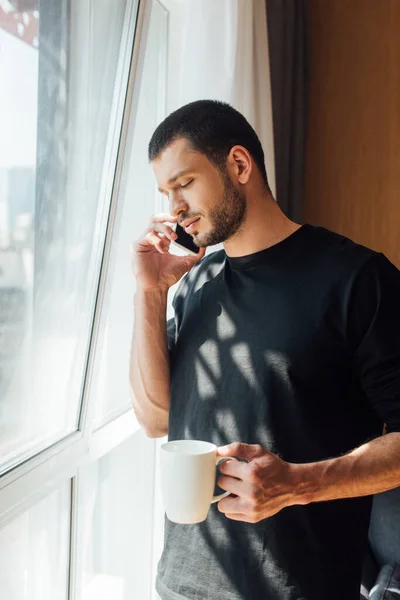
[266,0,308,221]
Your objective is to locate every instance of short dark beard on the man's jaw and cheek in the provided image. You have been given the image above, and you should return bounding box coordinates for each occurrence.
[193,173,247,248]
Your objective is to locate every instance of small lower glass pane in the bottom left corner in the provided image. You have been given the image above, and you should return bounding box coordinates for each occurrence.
[0,482,71,600]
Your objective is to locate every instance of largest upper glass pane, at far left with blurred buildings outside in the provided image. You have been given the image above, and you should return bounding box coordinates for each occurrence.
[0,0,126,470]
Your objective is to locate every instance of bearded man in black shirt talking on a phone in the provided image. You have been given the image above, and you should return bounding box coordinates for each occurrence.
[131,101,400,600]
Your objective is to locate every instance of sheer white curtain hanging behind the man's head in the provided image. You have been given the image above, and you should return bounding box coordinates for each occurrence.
[164,0,275,193]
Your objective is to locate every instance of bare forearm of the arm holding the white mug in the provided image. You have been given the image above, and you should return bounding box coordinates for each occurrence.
[292,432,400,504]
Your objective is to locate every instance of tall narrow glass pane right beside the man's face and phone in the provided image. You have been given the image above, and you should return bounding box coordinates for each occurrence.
[91,1,168,424]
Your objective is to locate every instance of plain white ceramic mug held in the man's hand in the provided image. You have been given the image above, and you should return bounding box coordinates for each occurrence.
[161,440,236,524]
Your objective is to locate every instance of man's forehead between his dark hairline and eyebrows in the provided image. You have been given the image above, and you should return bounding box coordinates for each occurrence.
[152,138,211,185]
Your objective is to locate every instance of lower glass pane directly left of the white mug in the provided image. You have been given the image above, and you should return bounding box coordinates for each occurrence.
[78,431,154,600]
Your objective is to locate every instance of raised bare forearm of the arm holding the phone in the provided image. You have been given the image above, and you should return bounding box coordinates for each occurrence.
[130,287,170,437]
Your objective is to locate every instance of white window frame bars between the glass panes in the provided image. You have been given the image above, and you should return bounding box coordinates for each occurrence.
[0,0,151,540]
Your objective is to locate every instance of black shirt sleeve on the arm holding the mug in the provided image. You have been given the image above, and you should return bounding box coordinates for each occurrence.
[349,254,400,433]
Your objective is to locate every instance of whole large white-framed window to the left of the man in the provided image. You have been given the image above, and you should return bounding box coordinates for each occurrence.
[0,0,168,600]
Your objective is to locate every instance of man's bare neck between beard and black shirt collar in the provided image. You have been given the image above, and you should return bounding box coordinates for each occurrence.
[224,190,301,257]
